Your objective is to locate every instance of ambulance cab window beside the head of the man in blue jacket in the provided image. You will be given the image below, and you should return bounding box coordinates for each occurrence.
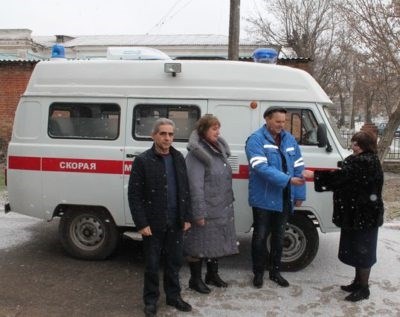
[285,109,318,145]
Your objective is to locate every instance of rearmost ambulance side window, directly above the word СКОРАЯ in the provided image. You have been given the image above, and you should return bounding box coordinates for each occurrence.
[48,103,121,140]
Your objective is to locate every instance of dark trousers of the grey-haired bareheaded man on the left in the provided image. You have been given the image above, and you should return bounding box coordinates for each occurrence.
[143,226,183,305]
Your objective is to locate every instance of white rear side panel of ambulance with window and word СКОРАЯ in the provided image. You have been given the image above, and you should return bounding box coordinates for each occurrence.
[39,97,126,225]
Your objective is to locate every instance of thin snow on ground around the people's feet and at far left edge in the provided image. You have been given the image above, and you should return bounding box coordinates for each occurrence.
[0,212,400,317]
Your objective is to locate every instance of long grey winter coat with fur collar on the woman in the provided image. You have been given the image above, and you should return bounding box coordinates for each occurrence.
[184,131,238,258]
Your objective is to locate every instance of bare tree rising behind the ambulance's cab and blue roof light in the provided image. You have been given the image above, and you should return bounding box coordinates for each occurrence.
[247,0,353,126]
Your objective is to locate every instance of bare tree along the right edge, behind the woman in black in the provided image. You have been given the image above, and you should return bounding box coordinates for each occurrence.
[339,0,400,160]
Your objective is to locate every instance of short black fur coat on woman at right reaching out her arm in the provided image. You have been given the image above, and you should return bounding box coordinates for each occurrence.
[314,152,384,230]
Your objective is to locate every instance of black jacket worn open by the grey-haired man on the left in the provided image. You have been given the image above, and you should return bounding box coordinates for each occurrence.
[128,145,190,230]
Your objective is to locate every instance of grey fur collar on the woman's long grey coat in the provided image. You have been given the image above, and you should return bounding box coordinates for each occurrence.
[187,130,231,166]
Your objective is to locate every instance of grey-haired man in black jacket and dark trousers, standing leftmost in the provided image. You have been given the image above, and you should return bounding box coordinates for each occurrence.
[128,118,192,316]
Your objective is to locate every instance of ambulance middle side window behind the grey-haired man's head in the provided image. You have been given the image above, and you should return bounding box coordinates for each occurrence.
[132,104,200,142]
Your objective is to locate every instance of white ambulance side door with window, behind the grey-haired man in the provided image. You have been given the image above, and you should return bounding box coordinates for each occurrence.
[124,99,207,225]
